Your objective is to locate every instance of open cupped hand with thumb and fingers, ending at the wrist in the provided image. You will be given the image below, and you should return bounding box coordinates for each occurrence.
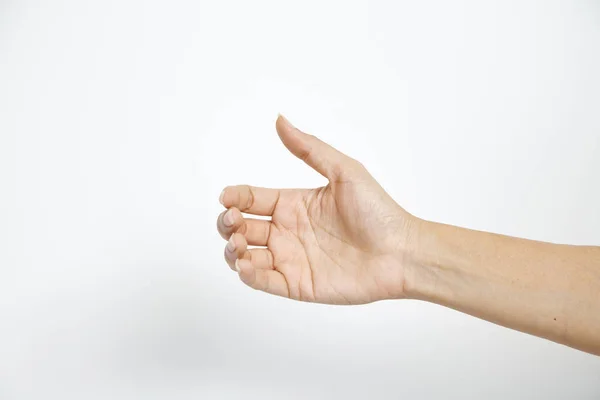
[217,116,417,304]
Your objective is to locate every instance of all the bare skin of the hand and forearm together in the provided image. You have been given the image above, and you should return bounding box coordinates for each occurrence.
[217,116,600,355]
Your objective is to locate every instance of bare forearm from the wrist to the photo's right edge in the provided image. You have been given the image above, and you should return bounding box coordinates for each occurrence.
[405,221,600,354]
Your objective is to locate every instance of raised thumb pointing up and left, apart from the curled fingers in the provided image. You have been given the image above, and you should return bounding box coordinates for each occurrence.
[275,114,359,180]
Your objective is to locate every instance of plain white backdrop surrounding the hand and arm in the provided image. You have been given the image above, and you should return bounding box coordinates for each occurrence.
[0,0,600,400]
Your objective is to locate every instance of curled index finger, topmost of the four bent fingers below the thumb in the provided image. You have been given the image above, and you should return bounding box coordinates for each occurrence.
[219,185,281,216]
